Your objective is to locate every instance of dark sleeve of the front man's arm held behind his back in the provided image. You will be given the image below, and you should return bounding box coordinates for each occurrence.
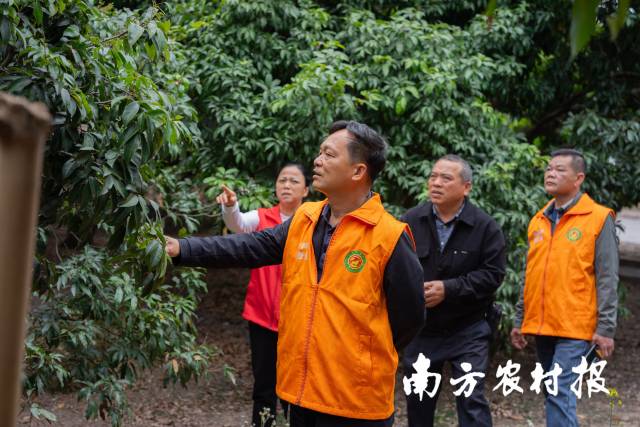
[383,233,425,351]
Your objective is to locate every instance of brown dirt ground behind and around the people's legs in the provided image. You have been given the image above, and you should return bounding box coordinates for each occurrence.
[19,270,640,427]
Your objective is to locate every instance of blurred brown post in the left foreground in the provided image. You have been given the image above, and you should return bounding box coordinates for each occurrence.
[0,93,51,426]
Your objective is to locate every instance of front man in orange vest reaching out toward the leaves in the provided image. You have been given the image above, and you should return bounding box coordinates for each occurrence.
[166,121,424,427]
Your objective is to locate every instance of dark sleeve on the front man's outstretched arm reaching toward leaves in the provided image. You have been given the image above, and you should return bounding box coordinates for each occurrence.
[173,220,291,268]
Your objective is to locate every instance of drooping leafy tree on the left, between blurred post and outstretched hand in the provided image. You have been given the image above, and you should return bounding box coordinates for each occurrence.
[0,0,212,424]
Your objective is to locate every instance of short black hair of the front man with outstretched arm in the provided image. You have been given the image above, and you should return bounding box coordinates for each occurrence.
[329,120,388,184]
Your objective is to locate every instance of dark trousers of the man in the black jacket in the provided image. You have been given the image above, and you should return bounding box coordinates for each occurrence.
[402,320,492,427]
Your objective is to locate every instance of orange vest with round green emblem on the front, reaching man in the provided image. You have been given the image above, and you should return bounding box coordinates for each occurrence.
[276,194,410,420]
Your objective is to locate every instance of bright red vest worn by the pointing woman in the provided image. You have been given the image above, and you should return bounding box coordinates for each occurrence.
[242,205,282,331]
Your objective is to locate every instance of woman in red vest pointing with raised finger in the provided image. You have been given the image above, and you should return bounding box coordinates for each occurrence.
[216,163,309,427]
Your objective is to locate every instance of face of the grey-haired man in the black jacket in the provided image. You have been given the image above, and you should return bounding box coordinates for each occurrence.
[428,160,471,206]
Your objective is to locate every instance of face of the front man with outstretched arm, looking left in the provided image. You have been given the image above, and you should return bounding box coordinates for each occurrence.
[313,129,358,196]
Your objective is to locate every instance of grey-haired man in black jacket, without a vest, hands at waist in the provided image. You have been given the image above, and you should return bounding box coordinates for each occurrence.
[402,155,506,427]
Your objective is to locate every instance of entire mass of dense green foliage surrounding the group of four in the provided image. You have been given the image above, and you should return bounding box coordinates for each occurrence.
[0,0,640,424]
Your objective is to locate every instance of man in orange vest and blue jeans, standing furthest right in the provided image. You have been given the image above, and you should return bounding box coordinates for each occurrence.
[511,149,618,426]
